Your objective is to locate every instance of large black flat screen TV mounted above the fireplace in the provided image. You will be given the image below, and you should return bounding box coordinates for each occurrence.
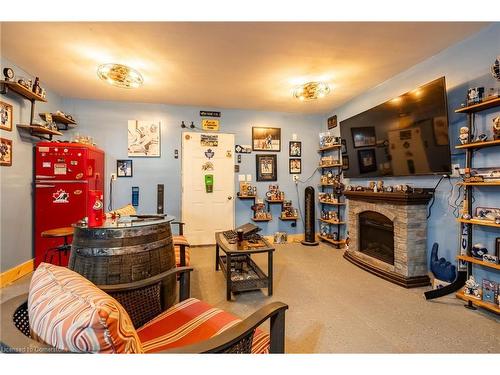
[340,77,451,178]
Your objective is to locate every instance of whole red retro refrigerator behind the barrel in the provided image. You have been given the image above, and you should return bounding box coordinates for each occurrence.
[33,142,104,267]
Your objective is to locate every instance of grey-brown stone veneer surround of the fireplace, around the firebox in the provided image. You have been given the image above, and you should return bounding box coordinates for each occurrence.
[347,199,428,277]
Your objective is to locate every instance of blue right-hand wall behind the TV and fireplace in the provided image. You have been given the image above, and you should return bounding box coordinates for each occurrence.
[333,23,500,281]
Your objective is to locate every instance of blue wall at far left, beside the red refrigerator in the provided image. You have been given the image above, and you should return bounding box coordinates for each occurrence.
[0,58,62,272]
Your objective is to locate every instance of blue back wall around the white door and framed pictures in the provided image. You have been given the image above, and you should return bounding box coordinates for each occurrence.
[60,99,323,234]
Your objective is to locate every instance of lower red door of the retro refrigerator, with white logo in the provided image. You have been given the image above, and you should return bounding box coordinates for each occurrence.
[33,181,88,267]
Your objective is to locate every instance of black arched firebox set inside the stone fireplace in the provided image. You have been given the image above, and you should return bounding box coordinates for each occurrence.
[359,211,394,265]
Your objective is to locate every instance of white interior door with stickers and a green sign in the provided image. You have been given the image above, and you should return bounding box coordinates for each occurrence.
[182,132,235,245]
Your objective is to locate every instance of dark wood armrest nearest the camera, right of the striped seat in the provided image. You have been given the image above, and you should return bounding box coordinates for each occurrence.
[159,302,288,354]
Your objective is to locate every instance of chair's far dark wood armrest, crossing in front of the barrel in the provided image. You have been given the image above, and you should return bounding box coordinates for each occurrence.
[97,267,193,301]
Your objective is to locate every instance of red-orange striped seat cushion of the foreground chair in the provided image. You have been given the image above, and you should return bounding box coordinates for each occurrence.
[137,298,270,354]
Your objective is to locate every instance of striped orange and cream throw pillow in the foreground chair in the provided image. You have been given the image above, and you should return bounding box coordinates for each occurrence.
[28,263,143,353]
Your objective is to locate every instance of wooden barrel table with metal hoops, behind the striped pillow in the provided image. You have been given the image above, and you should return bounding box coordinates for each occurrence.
[68,216,176,326]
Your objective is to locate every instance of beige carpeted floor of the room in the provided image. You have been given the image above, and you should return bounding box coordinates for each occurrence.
[1,244,500,353]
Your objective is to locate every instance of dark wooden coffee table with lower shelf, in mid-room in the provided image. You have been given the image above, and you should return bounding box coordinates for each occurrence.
[215,232,274,301]
